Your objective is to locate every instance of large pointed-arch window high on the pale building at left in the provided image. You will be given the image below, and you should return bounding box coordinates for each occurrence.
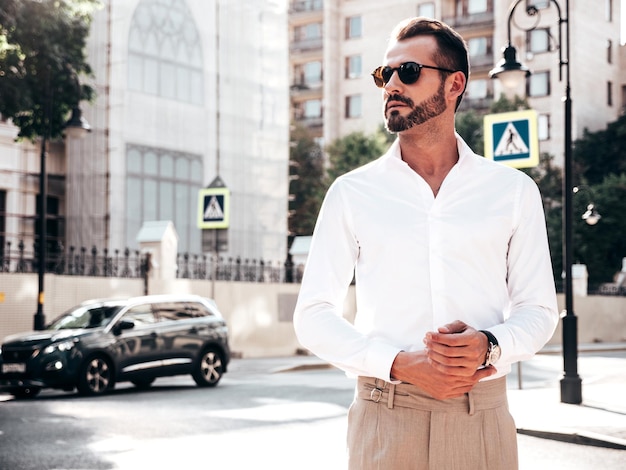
[128,0,204,105]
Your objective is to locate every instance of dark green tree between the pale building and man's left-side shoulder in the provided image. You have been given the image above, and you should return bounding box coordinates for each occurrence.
[289,126,325,235]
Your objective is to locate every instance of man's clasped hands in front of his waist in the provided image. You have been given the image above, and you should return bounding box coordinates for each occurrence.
[391,320,496,400]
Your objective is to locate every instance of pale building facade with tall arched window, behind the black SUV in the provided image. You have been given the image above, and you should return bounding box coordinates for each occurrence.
[0,0,289,261]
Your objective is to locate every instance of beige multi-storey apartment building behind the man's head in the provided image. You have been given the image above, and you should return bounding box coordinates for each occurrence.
[289,0,626,163]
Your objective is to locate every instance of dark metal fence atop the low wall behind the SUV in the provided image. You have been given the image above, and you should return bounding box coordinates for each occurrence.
[0,241,301,282]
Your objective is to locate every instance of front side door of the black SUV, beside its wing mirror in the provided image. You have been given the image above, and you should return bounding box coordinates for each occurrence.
[115,303,163,375]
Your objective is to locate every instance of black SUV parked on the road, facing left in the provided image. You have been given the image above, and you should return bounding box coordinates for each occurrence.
[0,295,230,398]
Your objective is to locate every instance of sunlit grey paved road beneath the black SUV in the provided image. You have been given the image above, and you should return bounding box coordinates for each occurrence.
[0,359,626,470]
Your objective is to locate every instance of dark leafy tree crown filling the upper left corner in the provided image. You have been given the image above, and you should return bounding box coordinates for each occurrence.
[0,0,99,140]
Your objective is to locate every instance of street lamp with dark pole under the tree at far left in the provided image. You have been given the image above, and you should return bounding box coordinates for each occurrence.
[34,103,91,330]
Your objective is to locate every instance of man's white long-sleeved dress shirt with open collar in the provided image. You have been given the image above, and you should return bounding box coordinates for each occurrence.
[294,135,558,380]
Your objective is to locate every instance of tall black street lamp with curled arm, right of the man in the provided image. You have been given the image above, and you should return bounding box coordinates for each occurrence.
[489,0,582,405]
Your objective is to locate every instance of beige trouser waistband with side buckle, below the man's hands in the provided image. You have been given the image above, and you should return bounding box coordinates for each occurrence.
[357,377,507,415]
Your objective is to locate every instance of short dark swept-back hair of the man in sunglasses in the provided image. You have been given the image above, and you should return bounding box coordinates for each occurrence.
[391,16,469,110]
